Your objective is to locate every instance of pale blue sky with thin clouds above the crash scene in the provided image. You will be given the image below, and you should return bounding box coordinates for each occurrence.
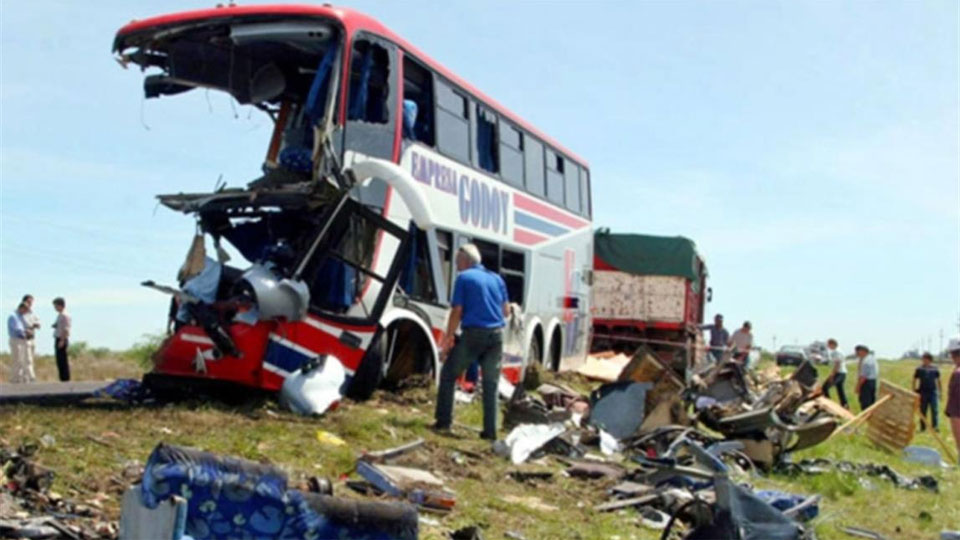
[0,0,960,355]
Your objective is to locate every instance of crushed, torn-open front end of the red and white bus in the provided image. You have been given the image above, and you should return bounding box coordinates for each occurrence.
[114,6,432,398]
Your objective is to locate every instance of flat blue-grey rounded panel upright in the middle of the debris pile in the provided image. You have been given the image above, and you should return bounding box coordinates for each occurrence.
[590,381,652,440]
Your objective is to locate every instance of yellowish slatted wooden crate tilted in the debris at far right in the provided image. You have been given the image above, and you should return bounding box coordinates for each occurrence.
[867,380,920,453]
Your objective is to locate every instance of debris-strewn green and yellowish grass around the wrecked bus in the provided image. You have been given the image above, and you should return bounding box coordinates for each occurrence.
[0,357,960,540]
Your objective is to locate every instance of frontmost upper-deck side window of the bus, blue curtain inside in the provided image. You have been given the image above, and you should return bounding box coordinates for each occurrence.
[347,40,390,124]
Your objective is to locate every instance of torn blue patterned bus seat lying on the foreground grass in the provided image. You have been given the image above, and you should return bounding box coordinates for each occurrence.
[141,443,417,540]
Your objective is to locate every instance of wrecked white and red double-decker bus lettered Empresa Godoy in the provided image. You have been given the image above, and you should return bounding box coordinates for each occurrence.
[113,5,593,399]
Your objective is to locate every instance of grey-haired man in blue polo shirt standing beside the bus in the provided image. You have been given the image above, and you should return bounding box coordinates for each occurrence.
[434,244,509,440]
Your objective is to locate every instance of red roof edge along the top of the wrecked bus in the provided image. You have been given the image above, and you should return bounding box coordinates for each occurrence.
[113,4,588,166]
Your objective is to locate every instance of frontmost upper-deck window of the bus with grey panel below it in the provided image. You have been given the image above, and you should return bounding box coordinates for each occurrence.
[343,32,399,161]
